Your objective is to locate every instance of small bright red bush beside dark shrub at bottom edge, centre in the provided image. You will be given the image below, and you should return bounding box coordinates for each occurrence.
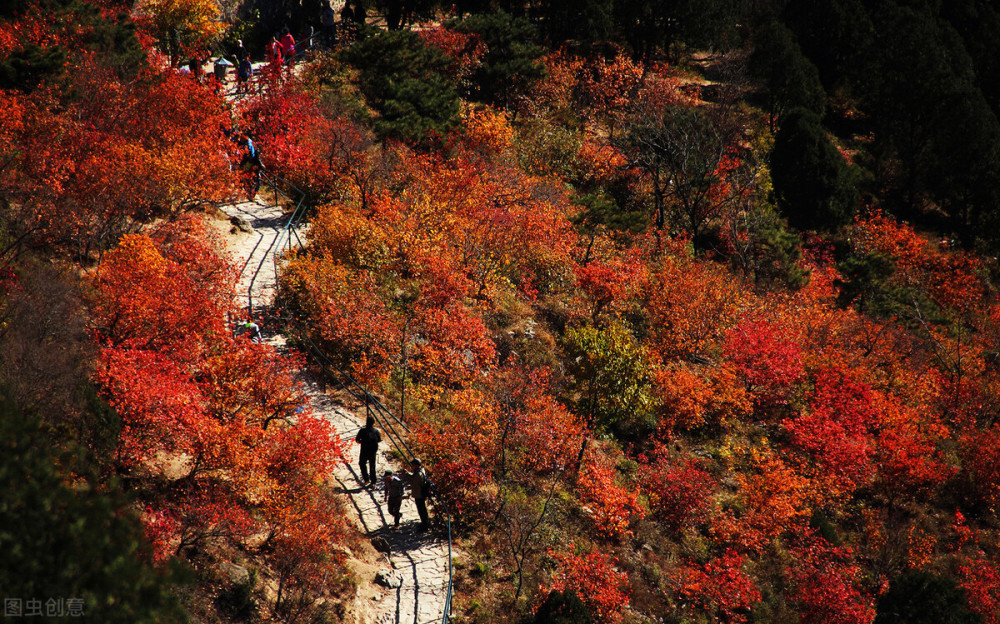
[542,547,631,624]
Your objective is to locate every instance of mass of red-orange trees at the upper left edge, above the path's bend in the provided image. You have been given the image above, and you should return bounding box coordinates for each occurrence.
[0,60,235,253]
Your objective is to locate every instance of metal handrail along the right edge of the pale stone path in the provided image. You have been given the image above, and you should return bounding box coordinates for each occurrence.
[247,167,454,624]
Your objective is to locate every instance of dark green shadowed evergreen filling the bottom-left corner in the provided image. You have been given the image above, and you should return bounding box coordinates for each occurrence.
[0,393,185,624]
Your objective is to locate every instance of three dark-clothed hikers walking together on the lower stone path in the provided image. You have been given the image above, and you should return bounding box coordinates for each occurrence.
[354,416,433,531]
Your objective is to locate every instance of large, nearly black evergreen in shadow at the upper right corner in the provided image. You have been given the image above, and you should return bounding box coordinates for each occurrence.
[865,5,1000,244]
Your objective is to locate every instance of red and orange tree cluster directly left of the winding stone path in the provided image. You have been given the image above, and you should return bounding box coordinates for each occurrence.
[93,220,342,587]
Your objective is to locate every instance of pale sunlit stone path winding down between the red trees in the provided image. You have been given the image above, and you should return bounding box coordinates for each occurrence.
[220,196,458,624]
